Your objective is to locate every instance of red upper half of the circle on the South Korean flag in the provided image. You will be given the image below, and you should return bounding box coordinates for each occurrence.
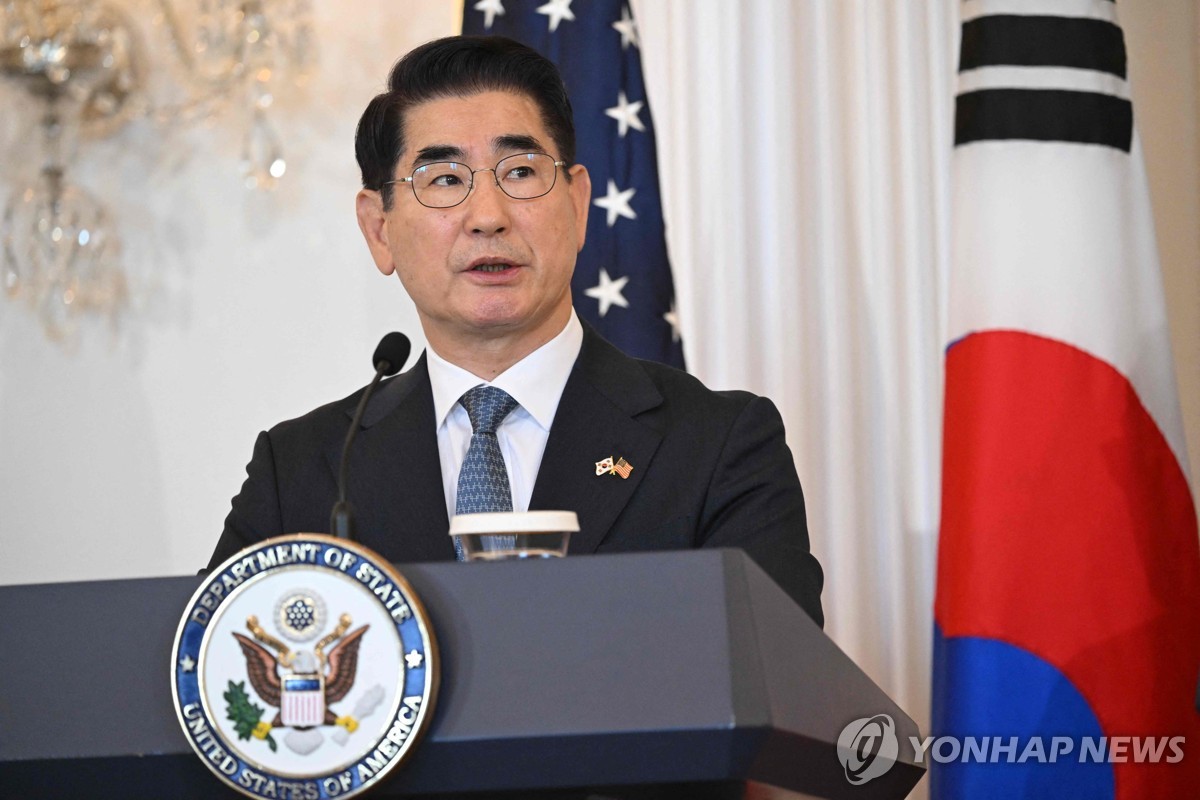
[935,331,1200,799]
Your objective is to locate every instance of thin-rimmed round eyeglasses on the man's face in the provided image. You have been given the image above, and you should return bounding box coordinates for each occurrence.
[384,152,566,209]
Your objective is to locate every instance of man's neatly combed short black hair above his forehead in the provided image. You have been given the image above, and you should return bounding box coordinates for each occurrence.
[354,36,575,209]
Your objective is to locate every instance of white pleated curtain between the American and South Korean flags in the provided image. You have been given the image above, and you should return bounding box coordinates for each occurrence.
[634,0,959,729]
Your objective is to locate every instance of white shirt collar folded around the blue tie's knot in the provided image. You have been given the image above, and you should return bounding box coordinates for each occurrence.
[428,308,583,431]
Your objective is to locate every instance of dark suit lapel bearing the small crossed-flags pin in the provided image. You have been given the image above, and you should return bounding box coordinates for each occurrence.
[529,324,662,553]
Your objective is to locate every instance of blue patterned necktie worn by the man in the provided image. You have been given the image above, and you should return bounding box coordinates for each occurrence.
[454,386,517,561]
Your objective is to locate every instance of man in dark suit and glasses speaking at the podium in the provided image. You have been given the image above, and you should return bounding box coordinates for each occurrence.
[212,37,823,624]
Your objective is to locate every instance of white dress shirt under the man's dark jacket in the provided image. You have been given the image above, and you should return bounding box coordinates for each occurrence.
[428,308,583,517]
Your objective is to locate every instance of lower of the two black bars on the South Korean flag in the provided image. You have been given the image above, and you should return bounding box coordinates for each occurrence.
[954,89,1133,152]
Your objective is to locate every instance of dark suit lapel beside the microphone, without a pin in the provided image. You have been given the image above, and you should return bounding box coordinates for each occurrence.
[330,354,454,561]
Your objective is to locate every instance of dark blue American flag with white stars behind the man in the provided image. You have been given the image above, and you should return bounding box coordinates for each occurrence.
[462,0,684,368]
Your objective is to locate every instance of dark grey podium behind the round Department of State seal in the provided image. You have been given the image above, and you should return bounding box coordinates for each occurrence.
[0,551,924,800]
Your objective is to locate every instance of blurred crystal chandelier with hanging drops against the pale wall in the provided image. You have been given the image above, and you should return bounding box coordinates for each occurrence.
[0,0,312,341]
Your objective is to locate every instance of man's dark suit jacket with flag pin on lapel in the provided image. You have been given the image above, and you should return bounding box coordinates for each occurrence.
[210,326,823,624]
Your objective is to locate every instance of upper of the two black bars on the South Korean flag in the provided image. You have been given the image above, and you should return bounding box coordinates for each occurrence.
[959,14,1126,78]
